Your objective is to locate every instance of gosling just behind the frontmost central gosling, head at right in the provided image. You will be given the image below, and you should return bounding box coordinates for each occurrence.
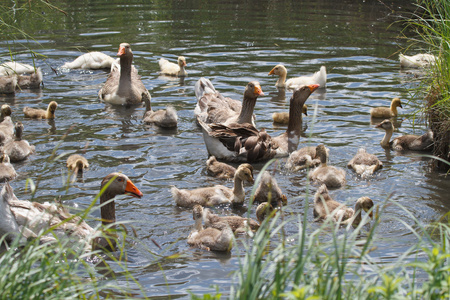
[203,202,274,234]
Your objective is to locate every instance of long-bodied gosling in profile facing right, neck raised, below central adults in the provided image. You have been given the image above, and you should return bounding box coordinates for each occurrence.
[171,165,253,207]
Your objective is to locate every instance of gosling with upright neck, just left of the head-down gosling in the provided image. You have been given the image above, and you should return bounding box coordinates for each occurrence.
[308,144,347,188]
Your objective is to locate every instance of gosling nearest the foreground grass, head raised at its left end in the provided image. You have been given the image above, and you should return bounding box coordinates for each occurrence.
[188,205,233,252]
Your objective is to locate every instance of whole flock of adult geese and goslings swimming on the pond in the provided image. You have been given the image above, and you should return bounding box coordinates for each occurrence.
[0,43,433,251]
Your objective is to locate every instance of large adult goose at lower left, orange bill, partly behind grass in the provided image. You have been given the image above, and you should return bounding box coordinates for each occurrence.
[0,173,142,251]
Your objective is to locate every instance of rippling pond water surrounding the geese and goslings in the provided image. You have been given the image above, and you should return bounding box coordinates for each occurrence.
[0,0,450,298]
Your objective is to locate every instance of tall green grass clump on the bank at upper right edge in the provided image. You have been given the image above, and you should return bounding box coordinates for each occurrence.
[408,0,450,171]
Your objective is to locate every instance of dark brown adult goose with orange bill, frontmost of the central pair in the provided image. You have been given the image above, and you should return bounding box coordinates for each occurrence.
[197,84,319,162]
